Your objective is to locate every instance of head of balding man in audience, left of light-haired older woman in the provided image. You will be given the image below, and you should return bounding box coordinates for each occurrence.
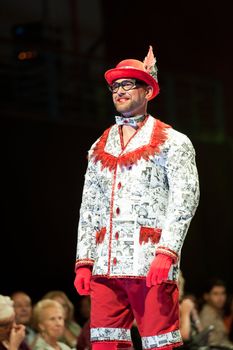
[11,291,32,326]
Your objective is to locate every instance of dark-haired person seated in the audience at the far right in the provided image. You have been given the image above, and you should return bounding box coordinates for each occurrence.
[200,279,233,349]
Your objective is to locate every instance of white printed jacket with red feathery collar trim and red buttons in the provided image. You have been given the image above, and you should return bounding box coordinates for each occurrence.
[76,116,199,281]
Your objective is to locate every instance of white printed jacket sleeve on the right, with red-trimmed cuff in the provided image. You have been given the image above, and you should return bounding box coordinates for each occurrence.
[156,134,199,262]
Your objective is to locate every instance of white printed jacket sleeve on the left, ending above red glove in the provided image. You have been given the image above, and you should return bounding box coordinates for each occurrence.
[75,151,100,269]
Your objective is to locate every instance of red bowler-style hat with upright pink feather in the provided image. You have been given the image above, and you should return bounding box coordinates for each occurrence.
[104,46,159,100]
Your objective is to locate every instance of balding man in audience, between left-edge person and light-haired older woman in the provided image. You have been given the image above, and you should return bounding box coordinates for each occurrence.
[11,291,36,346]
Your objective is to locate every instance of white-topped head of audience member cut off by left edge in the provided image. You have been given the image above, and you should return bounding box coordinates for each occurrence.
[0,295,15,342]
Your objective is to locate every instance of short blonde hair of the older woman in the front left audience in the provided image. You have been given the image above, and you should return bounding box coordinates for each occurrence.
[33,299,64,331]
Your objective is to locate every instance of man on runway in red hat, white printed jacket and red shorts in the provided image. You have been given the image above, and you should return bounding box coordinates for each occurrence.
[74,47,199,350]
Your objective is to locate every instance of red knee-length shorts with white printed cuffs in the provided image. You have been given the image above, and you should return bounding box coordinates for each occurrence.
[91,277,182,349]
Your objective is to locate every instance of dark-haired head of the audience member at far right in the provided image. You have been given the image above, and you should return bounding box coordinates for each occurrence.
[203,278,227,310]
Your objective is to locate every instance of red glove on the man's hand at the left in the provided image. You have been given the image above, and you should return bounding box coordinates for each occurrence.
[74,266,91,295]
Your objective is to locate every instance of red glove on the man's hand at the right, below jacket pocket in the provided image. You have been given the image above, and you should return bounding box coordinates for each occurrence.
[146,253,173,287]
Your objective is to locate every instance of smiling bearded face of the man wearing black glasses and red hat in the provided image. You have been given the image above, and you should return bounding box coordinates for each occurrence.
[112,78,152,116]
